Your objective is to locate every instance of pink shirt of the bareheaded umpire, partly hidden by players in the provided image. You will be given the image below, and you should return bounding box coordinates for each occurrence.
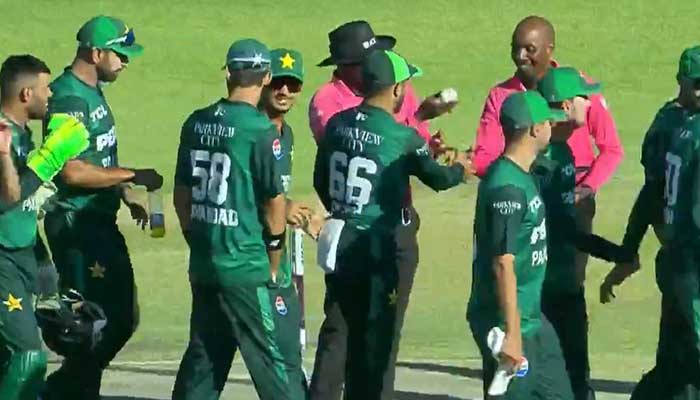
[474,71,624,192]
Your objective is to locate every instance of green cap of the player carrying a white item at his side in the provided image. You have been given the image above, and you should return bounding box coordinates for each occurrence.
[500,90,567,132]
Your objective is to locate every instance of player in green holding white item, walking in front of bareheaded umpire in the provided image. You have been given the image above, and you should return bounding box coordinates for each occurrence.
[467,91,573,400]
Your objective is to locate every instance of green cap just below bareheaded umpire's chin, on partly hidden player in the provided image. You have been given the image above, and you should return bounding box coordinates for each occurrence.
[537,67,600,103]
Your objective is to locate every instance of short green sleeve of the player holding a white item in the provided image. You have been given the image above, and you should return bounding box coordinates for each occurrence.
[486,186,527,256]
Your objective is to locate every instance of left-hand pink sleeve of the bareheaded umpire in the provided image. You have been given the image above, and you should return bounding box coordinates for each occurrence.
[473,89,505,177]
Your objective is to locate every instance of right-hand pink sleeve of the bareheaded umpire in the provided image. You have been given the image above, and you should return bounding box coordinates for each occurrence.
[580,96,624,191]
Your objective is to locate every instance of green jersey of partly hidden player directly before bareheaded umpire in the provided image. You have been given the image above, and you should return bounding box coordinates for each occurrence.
[532,141,580,292]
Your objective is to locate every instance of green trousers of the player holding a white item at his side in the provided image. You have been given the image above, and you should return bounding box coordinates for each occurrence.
[470,317,574,400]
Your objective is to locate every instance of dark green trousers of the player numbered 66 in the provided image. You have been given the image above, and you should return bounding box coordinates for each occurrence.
[333,228,399,400]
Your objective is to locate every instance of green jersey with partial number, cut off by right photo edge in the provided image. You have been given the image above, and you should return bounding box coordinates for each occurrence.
[664,114,700,249]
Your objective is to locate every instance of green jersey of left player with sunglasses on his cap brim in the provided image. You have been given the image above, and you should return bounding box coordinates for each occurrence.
[44,68,121,215]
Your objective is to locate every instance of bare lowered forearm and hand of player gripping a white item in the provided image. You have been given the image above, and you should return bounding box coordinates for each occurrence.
[493,254,523,369]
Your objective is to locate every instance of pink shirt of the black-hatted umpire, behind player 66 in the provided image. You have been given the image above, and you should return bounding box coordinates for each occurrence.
[309,76,430,143]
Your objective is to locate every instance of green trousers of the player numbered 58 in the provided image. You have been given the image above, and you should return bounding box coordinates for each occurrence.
[172,284,292,400]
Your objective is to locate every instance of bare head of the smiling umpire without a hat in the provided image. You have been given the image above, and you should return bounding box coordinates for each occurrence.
[510,17,554,89]
